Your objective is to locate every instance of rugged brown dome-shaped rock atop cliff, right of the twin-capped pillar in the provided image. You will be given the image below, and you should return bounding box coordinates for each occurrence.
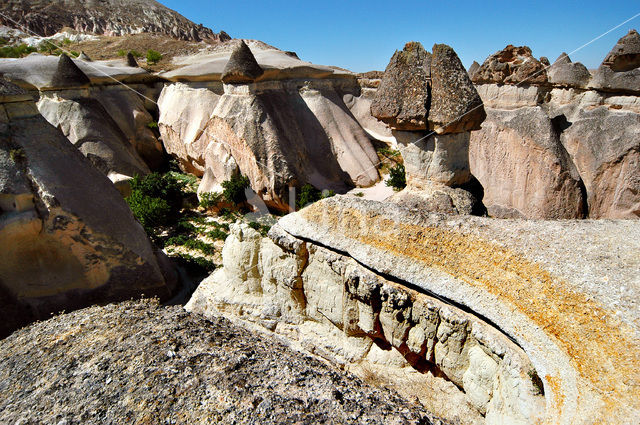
[473,44,547,84]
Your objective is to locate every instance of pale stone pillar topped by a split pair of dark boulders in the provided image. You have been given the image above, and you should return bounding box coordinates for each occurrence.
[371,42,486,214]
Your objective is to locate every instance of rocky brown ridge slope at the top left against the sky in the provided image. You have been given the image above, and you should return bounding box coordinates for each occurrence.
[0,0,230,41]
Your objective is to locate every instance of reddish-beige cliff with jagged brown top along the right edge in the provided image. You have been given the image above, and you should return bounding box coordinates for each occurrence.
[469,31,640,218]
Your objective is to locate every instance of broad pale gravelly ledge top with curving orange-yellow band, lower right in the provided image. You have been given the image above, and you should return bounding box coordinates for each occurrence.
[278,196,640,423]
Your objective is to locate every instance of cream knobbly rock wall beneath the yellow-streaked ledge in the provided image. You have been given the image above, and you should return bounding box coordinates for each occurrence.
[186,224,544,424]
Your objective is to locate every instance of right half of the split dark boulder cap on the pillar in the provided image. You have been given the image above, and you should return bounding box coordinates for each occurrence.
[428,44,487,134]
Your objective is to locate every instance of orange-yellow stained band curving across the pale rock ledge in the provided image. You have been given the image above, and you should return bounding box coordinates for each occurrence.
[301,204,640,416]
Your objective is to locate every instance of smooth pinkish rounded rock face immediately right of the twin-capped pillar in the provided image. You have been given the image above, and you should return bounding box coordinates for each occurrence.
[469,106,587,219]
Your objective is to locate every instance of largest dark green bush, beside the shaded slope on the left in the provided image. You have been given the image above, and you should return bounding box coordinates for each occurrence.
[126,173,185,236]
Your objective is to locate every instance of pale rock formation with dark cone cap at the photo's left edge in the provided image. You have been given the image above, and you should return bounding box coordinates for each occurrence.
[0,54,163,186]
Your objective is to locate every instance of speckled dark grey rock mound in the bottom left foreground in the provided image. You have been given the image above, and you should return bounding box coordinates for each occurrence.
[0,301,443,425]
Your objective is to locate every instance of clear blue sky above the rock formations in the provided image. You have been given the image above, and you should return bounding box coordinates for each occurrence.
[160,0,640,72]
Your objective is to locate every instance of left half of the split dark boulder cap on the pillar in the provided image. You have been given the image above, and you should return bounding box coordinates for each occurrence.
[371,41,431,130]
